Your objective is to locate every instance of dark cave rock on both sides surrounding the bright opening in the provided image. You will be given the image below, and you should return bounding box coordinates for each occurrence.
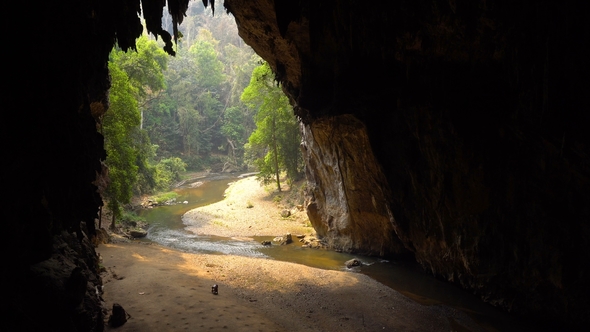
[0,0,590,331]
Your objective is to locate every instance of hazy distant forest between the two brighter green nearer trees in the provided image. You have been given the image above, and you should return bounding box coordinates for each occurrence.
[144,15,258,170]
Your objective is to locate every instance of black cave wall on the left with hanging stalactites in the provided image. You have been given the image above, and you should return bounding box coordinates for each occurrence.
[0,0,188,331]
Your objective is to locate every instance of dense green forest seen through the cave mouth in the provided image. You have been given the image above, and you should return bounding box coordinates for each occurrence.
[99,1,303,225]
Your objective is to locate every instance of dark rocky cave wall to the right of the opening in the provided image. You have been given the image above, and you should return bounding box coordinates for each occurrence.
[225,0,590,326]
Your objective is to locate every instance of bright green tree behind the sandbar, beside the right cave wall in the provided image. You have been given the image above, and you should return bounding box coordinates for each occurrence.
[241,63,301,191]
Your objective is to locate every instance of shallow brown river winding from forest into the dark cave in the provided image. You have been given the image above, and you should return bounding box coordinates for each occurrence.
[140,176,530,331]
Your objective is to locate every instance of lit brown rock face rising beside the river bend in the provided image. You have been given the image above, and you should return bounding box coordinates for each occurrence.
[302,115,407,256]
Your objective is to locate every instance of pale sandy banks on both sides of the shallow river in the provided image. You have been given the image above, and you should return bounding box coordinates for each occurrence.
[97,178,481,331]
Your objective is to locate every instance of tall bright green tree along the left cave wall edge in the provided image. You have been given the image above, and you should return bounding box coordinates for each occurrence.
[102,36,168,227]
